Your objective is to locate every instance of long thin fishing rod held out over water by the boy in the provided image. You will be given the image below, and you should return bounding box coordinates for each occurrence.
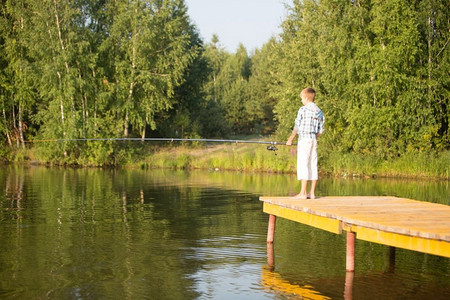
[27,138,295,155]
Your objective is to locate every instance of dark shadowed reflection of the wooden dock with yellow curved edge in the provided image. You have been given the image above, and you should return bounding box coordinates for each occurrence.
[261,219,450,300]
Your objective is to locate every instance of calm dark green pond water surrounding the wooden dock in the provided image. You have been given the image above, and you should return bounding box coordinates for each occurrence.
[0,166,450,299]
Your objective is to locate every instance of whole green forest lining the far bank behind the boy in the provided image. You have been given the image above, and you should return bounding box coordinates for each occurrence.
[0,0,450,176]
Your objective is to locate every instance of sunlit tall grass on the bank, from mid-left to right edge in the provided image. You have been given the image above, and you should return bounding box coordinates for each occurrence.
[134,144,450,180]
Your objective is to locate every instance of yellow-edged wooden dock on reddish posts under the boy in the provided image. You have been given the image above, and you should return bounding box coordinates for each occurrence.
[260,196,450,271]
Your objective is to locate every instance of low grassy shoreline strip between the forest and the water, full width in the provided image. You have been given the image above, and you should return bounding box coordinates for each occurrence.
[0,145,450,181]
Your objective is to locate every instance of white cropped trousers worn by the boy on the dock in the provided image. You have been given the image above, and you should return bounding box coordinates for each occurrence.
[297,138,319,180]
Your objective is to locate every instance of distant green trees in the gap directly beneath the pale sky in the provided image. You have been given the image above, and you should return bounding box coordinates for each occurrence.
[200,37,275,136]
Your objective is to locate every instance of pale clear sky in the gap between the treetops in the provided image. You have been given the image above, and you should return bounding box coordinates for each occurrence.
[185,0,286,52]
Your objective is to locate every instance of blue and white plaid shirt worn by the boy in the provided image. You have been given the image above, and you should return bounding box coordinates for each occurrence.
[294,103,325,139]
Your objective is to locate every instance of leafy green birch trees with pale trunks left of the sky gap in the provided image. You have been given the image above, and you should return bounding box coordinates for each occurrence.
[0,0,204,165]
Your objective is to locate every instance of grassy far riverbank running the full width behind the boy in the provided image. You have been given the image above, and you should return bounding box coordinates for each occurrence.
[6,143,450,180]
